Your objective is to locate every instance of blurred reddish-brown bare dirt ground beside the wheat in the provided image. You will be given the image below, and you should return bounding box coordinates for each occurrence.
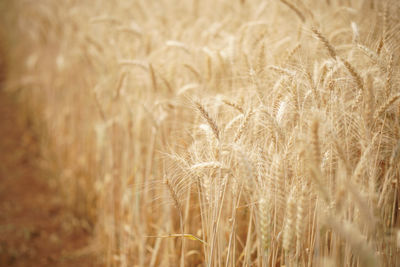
[0,89,99,267]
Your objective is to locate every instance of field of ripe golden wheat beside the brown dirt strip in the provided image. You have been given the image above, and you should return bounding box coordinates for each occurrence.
[0,0,400,266]
